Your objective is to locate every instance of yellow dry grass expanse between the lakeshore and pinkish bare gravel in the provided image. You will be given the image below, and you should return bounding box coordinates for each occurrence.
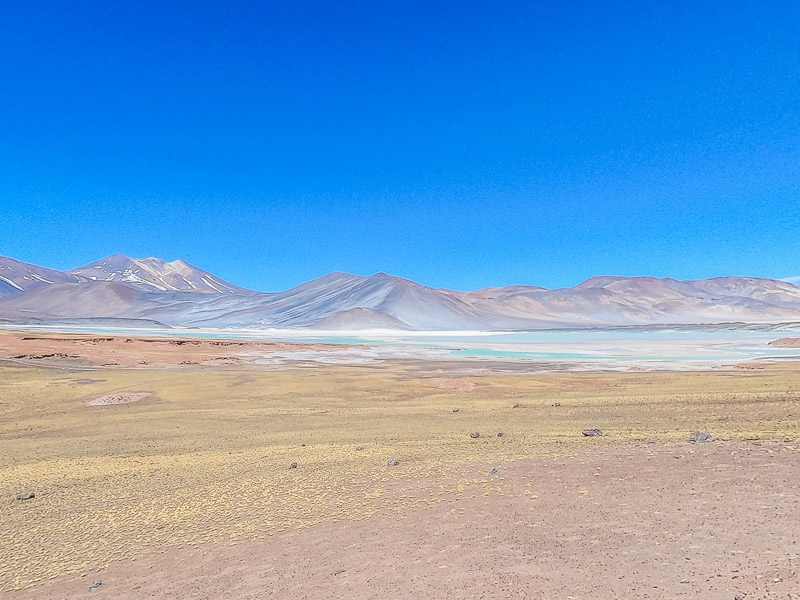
[0,364,800,591]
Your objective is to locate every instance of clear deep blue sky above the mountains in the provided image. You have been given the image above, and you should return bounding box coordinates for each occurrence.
[0,0,800,291]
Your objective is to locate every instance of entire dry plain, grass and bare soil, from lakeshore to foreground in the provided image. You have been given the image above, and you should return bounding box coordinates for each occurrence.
[0,331,800,600]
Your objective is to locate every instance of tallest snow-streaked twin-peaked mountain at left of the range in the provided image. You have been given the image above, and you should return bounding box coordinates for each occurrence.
[69,254,247,294]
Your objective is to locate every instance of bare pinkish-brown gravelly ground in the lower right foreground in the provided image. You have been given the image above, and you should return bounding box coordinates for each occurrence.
[13,443,800,600]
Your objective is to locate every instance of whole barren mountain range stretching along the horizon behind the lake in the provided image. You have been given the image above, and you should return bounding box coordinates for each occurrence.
[0,254,800,330]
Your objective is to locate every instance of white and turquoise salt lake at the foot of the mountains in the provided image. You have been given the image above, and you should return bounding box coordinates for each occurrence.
[1,326,800,364]
